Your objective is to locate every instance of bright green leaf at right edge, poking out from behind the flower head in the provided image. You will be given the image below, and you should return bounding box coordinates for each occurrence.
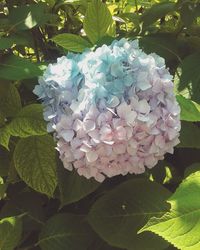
[176,95,200,122]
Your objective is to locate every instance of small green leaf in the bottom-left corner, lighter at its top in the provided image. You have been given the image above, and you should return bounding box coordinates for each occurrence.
[0,217,22,250]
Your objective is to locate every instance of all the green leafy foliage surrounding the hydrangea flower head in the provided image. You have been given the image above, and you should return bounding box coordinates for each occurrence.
[0,0,200,250]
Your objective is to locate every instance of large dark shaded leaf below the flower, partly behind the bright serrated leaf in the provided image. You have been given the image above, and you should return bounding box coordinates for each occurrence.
[89,179,170,250]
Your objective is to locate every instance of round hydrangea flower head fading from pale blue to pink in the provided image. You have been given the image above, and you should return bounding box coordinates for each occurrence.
[34,39,180,182]
